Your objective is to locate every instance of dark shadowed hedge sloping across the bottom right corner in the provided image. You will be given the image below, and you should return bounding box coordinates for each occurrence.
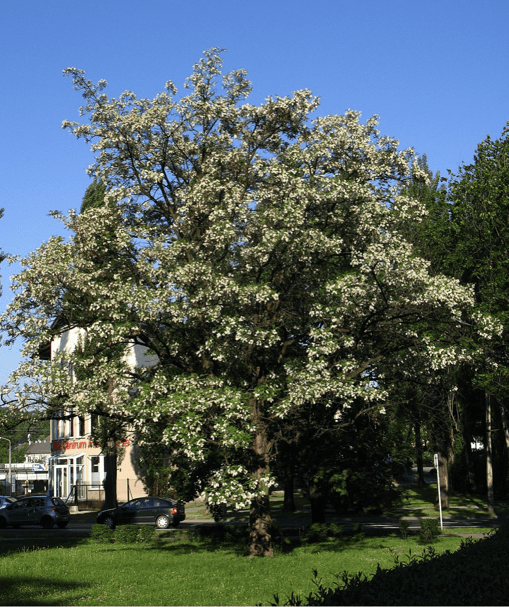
[272,526,509,605]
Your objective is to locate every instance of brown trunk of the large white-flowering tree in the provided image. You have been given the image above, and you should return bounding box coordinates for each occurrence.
[246,398,274,556]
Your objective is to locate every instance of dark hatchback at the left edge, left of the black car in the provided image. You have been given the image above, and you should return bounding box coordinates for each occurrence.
[0,495,71,529]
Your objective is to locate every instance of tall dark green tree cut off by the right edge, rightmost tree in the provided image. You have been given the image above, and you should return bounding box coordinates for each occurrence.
[448,123,509,507]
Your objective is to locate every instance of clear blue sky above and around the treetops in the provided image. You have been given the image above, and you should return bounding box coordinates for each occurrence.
[0,0,509,382]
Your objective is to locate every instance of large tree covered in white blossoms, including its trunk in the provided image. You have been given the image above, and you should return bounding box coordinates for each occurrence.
[3,49,472,555]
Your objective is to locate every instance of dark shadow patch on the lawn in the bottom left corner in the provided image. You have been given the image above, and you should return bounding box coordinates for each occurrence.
[0,576,93,605]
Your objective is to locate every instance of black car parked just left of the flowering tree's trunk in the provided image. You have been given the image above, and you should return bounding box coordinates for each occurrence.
[97,497,186,529]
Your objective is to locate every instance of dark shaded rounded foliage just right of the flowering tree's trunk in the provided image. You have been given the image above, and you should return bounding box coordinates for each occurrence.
[279,402,408,522]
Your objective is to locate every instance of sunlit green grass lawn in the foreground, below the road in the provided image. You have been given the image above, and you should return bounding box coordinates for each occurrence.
[0,534,472,605]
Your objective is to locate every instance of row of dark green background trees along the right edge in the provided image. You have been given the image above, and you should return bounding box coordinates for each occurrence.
[401,126,509,509]
